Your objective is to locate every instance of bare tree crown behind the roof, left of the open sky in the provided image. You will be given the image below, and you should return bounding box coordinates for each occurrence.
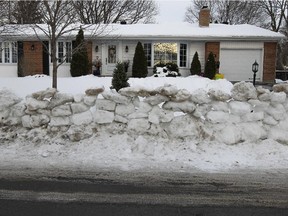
[73,0,158,24]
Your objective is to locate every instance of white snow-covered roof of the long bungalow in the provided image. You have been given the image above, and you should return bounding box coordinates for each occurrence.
[0,22,284,41]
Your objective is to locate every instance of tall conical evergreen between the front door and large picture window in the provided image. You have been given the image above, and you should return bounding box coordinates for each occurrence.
[132,42,148,78]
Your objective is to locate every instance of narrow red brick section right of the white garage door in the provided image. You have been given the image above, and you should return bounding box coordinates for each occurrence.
[263,42,277,82]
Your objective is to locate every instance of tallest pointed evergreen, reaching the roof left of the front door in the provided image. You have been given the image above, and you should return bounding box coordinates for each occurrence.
[70,29,89,77]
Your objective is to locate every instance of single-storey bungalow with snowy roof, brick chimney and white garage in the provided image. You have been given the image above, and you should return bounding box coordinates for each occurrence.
[0,8,284,82]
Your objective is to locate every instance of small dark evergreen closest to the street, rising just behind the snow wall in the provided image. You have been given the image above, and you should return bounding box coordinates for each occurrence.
[112,62,129,92]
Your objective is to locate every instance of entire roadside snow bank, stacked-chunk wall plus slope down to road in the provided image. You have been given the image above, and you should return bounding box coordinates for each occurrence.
[0,78,288,170]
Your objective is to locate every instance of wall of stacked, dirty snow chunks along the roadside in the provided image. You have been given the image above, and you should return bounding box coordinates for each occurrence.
[0,82,288,144]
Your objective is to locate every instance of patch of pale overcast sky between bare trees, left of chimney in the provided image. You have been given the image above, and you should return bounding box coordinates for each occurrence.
[155,0,192,23]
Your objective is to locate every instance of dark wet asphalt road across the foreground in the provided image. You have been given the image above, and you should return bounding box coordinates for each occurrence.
[0,170,288,216]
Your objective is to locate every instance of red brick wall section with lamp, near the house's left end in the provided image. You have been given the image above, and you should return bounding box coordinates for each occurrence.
[21,41,43,76]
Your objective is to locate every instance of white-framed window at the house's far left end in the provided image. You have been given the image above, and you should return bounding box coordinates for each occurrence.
[0,42,18,64]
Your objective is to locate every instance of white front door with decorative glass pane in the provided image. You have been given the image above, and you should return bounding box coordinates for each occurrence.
[102,44,118,76]
